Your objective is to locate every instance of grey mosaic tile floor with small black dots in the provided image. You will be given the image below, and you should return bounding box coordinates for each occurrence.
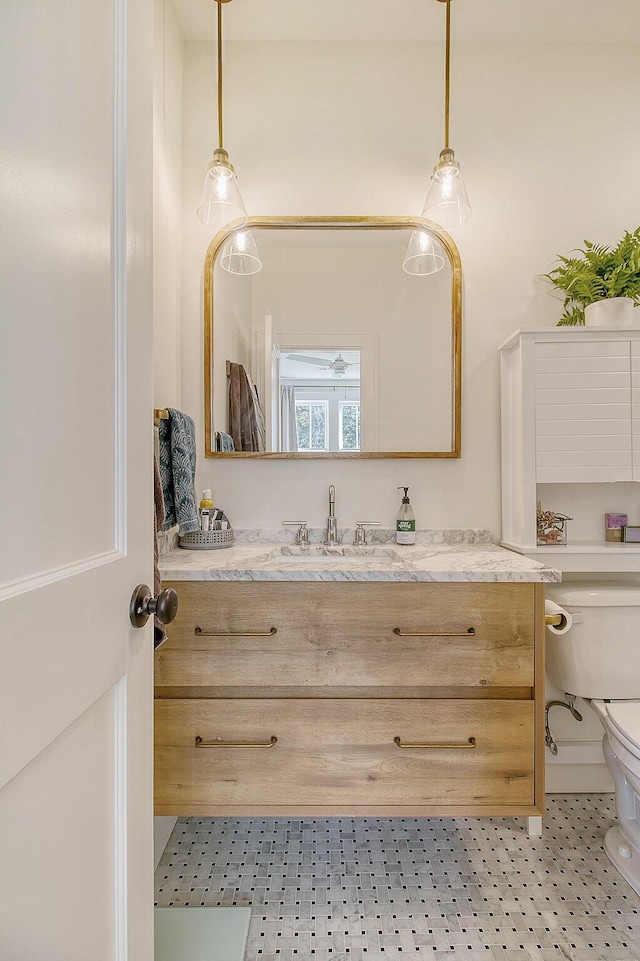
[156,795,640,961]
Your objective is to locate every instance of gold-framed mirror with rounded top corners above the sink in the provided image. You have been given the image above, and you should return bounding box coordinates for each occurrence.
[204,217,462,459]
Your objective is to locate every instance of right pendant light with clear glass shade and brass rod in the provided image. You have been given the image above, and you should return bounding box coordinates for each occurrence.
[422,0,471,227]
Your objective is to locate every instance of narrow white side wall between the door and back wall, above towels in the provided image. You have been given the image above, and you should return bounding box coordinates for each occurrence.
[153,0,183,407]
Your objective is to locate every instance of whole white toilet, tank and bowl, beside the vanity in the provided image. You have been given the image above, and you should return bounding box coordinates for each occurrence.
[546,581,640,894]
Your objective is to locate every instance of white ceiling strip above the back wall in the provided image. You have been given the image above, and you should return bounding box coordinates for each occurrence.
[168,0,640,43]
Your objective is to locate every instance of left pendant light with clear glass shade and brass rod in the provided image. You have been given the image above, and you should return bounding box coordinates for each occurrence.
[198,0,247,230]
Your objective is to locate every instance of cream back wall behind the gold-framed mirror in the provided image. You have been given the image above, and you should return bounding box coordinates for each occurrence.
[181,42,640,538]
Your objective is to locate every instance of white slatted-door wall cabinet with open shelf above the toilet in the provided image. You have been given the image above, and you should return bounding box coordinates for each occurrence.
[499,327,640,571]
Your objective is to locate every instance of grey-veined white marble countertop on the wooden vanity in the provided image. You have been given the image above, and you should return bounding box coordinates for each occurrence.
[159,530,561,583]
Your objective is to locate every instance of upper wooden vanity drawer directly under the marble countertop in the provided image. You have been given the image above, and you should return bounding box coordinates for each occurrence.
[155,581,534,696]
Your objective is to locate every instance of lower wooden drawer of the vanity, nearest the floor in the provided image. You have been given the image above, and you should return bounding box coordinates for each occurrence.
[155,698,534,815]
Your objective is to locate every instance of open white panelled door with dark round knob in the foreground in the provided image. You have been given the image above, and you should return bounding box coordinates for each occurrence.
[0,0,153,961]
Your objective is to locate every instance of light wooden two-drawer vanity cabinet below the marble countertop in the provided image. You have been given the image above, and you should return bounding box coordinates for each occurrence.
[155,568,544,817]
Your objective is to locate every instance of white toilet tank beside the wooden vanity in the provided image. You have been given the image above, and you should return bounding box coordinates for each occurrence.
[546,581,640,700]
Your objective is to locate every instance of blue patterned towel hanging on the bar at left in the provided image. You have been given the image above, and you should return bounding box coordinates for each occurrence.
[159,407,200,534]
